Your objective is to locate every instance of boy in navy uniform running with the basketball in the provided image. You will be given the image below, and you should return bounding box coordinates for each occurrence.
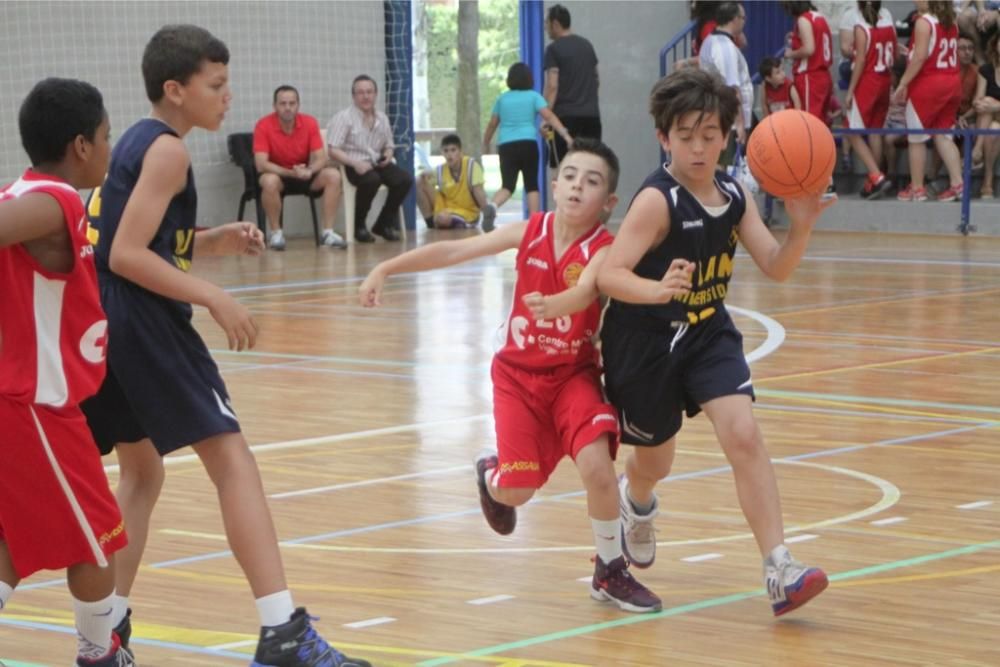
[598,69,832,615]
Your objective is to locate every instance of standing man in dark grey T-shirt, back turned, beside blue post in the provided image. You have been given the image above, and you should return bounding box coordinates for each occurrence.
[544,5,601,167]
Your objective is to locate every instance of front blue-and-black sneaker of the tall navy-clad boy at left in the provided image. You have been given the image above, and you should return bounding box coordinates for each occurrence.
[250,607,372,667]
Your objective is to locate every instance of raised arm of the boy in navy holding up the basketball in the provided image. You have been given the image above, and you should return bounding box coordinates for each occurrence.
[739,186,837,282]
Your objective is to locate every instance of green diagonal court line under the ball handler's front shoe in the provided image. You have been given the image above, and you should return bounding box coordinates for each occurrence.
[417,540,1000,667]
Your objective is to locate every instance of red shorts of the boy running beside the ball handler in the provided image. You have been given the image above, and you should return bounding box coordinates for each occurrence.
[491,358,618,489]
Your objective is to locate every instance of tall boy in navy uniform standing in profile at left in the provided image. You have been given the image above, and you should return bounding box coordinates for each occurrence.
[84,25,368,667]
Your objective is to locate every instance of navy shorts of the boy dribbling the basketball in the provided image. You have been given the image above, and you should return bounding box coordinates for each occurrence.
[601,309,754,446]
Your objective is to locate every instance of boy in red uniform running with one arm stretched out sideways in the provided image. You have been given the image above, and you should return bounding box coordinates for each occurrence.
[360,139,661,612]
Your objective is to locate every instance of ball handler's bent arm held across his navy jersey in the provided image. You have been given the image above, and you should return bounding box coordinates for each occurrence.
[597,188,694,303]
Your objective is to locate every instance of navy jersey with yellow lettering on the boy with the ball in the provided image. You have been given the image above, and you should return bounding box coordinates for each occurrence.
[605,167,747,330]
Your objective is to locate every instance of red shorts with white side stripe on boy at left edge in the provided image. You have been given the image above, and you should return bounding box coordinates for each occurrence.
[0,397,128,579]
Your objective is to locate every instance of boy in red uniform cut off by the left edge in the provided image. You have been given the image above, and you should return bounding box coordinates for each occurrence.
[0,79,133,667]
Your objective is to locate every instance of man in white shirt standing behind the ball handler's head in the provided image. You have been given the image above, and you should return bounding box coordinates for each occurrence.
[698,2,753,146]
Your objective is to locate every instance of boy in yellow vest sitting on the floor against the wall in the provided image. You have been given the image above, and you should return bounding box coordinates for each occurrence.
[417,134,486,229]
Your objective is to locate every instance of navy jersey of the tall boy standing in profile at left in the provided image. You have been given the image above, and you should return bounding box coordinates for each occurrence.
[96,118,198,294]
